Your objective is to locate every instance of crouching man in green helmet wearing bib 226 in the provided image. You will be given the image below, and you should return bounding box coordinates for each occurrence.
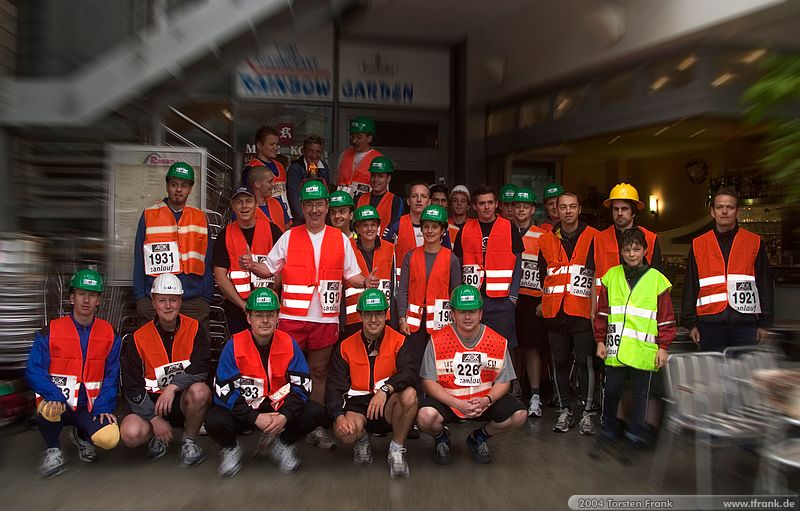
[417,284,528,465]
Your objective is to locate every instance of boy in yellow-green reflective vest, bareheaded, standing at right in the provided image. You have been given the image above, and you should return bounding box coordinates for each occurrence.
[591,228,675,462]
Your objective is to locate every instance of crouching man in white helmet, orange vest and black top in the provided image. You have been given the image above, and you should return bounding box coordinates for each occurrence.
[120,273,211,467]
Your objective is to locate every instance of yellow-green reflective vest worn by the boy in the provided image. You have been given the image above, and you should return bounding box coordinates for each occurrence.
[601,265,672,371]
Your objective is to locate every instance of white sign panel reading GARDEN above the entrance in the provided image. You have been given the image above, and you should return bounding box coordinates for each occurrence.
[339,42,450,108]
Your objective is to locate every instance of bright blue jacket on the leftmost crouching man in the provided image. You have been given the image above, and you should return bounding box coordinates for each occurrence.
[25,314,122,417]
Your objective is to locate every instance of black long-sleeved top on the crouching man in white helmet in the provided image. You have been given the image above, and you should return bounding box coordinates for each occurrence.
[121,317,211,420]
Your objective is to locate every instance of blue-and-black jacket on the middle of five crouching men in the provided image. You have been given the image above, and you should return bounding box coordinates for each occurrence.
[214,332,311,426]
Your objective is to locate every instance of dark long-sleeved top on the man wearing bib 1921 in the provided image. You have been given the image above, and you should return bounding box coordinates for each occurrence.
[681,226,775,329]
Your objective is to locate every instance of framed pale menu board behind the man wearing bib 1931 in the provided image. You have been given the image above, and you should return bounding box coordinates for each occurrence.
[106,145,206,286]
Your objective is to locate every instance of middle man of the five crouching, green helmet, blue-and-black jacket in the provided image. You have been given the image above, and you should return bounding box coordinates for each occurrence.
[206,287,325,477]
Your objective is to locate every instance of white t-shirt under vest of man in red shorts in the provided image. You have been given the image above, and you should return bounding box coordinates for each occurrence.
[264,226,361,323]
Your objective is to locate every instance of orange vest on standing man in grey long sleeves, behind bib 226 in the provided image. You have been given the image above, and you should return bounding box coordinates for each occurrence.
[406,247,453,333]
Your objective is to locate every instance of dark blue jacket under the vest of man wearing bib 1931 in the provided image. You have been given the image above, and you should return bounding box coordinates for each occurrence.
[133,199,214,302]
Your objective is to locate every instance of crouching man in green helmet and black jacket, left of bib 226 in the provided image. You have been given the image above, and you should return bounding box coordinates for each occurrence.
[325,289,417,477]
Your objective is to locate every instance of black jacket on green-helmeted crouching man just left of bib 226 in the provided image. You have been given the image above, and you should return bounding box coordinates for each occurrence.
[325,331,417,419]
